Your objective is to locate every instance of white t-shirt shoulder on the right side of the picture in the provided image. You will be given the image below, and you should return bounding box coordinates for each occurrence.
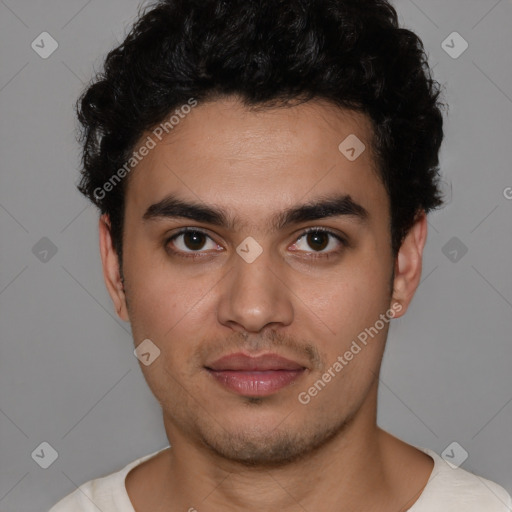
[410,448,512,512]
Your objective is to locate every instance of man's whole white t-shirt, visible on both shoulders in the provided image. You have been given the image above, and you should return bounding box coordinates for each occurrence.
[49,446,512,512]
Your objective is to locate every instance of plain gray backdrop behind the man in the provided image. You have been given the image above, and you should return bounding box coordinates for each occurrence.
[0,0,512,512]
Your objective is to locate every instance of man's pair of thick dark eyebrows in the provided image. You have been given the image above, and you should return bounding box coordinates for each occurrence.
[142,194,369,231]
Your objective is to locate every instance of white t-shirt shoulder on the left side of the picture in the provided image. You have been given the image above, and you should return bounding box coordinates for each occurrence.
[49,450,168,512]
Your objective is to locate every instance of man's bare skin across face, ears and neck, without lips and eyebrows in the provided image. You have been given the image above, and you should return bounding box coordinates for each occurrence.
[99,98,433,512]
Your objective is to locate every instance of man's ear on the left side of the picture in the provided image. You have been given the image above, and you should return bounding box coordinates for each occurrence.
[98,214,130,322]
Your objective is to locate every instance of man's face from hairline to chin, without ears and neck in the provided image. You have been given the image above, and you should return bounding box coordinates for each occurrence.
[111,99,404,464]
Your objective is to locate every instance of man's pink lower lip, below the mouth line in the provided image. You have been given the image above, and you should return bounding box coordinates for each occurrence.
[208,369,304,396]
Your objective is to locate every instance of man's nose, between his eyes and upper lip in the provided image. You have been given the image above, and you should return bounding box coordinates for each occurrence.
[217,246,294,333]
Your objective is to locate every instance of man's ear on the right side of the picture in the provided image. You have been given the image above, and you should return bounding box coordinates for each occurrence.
[391,210,427,317]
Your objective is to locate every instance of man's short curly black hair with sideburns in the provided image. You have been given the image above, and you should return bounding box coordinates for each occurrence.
[76,0,444,272]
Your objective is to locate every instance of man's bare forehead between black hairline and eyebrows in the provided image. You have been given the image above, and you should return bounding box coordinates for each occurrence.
[126,99,387,230]
